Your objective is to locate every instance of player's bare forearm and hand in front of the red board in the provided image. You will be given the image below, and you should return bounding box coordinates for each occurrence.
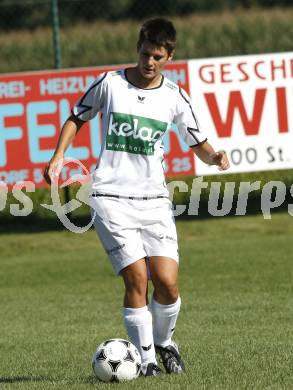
[44,115,84,184]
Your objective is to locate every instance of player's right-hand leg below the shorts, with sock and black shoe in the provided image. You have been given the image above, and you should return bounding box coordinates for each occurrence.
[150,256,184,373]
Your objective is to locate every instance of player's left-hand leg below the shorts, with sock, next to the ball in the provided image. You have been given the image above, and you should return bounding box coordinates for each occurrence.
[120,259,161,376]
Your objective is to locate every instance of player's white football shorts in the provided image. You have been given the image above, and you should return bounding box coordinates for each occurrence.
[91,195,178,275]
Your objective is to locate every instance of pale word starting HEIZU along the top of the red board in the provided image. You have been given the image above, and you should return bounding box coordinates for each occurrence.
[39,76,95,96]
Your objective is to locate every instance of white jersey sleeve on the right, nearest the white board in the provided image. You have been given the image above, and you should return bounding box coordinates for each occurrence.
[173,88,207,147]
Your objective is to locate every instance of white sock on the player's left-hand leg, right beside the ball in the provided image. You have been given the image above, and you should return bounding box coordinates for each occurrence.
[123,306,157,364]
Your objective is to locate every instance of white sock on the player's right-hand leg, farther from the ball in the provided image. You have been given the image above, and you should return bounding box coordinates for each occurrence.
[151,297,181,347]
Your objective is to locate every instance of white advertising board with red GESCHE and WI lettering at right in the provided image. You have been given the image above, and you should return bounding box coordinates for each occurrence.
[188,53,293,175]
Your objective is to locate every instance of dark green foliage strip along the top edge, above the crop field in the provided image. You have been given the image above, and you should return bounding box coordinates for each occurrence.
[0,0,292,31]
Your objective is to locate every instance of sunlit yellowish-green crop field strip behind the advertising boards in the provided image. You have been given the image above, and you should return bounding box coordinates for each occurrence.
[0,8,293,72]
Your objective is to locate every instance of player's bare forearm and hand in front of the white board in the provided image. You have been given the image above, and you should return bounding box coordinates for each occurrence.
[191,141,230,171]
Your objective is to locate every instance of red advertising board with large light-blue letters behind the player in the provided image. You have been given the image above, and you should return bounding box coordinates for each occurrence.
[0,62,194,186]
